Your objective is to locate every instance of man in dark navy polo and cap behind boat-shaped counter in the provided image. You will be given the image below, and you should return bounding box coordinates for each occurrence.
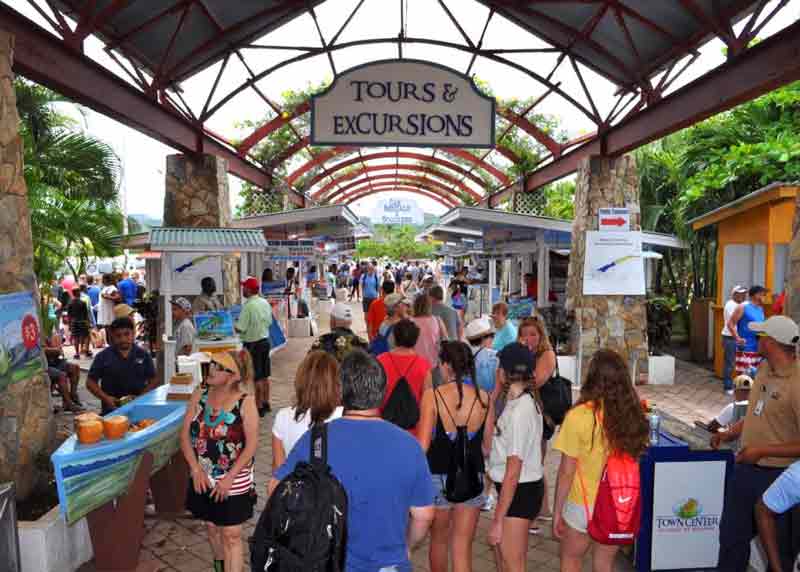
[86,318,159,415]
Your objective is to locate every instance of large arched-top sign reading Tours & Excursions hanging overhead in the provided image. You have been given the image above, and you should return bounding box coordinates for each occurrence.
[311,59,495,149]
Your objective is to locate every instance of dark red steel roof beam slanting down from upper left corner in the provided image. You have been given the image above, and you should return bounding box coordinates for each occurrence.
[0,2,305,206]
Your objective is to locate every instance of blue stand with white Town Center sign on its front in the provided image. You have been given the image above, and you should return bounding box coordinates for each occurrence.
[635,432,734,572]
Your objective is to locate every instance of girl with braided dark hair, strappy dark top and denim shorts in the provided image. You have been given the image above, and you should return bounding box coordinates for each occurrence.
[417,341,493,572]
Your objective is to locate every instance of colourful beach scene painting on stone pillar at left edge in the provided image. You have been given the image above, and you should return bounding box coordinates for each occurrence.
[0,292,44,392]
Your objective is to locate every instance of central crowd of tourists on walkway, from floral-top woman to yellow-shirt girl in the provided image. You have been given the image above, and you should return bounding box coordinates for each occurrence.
[169,265,648,572]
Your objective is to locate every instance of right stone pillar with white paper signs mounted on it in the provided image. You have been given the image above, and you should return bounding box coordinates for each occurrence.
[567,155,648,381]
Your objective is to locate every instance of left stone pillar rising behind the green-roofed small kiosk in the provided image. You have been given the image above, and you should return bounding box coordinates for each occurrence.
[164,151,240,305]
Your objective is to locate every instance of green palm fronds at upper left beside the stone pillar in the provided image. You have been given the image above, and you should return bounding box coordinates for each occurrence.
[14,79,130,282]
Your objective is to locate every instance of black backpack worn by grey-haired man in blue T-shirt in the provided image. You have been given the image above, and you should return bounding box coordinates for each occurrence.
[250,423,347,572]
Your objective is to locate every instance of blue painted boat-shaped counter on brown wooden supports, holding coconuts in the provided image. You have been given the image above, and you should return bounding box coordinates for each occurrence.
[51,386,189,570]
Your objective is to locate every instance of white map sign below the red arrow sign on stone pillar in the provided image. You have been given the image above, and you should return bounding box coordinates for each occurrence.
[583,231,645,296]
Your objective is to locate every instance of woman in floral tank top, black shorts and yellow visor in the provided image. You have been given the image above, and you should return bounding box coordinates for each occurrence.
[181,350,259,572]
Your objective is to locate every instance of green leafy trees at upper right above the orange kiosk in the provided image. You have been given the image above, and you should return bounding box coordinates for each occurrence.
[636,82,800,309]
